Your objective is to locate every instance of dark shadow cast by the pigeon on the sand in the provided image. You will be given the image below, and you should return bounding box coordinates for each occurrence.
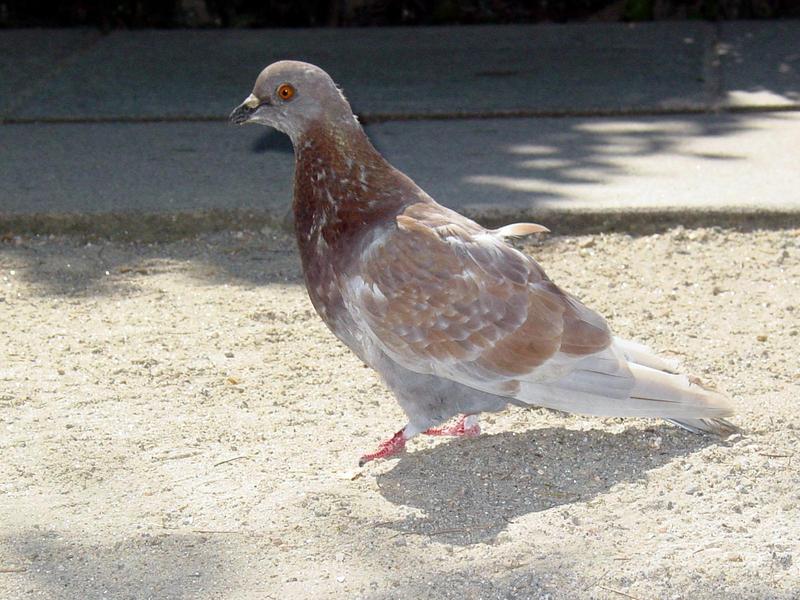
[377,425,718,545]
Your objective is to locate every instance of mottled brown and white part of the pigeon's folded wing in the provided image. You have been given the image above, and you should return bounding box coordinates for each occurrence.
[347,205,617,400]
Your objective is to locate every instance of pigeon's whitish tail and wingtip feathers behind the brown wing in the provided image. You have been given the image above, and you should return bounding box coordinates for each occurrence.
[516,339,736,436]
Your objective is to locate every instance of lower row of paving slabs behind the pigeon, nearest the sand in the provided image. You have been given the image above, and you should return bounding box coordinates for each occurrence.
[0,112,800,219]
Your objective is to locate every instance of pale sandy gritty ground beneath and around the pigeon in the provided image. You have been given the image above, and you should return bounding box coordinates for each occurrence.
[0,224,800,600]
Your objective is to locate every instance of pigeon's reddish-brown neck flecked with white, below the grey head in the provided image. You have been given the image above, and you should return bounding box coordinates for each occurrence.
[293,119,419,251]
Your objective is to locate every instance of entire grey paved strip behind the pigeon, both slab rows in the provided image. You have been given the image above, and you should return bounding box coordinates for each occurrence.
[0,21,800,227]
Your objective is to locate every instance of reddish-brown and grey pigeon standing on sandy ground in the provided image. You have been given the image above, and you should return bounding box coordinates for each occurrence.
[230,61,737,465]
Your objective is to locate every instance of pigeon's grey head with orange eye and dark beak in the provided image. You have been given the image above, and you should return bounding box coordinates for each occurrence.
[230,60,355,140]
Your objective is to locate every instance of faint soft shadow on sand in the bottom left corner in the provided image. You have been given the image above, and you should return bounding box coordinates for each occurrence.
[3,530,241,600]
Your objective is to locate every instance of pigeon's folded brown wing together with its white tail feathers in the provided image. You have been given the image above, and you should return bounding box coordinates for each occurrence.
[344,205,732,426]
